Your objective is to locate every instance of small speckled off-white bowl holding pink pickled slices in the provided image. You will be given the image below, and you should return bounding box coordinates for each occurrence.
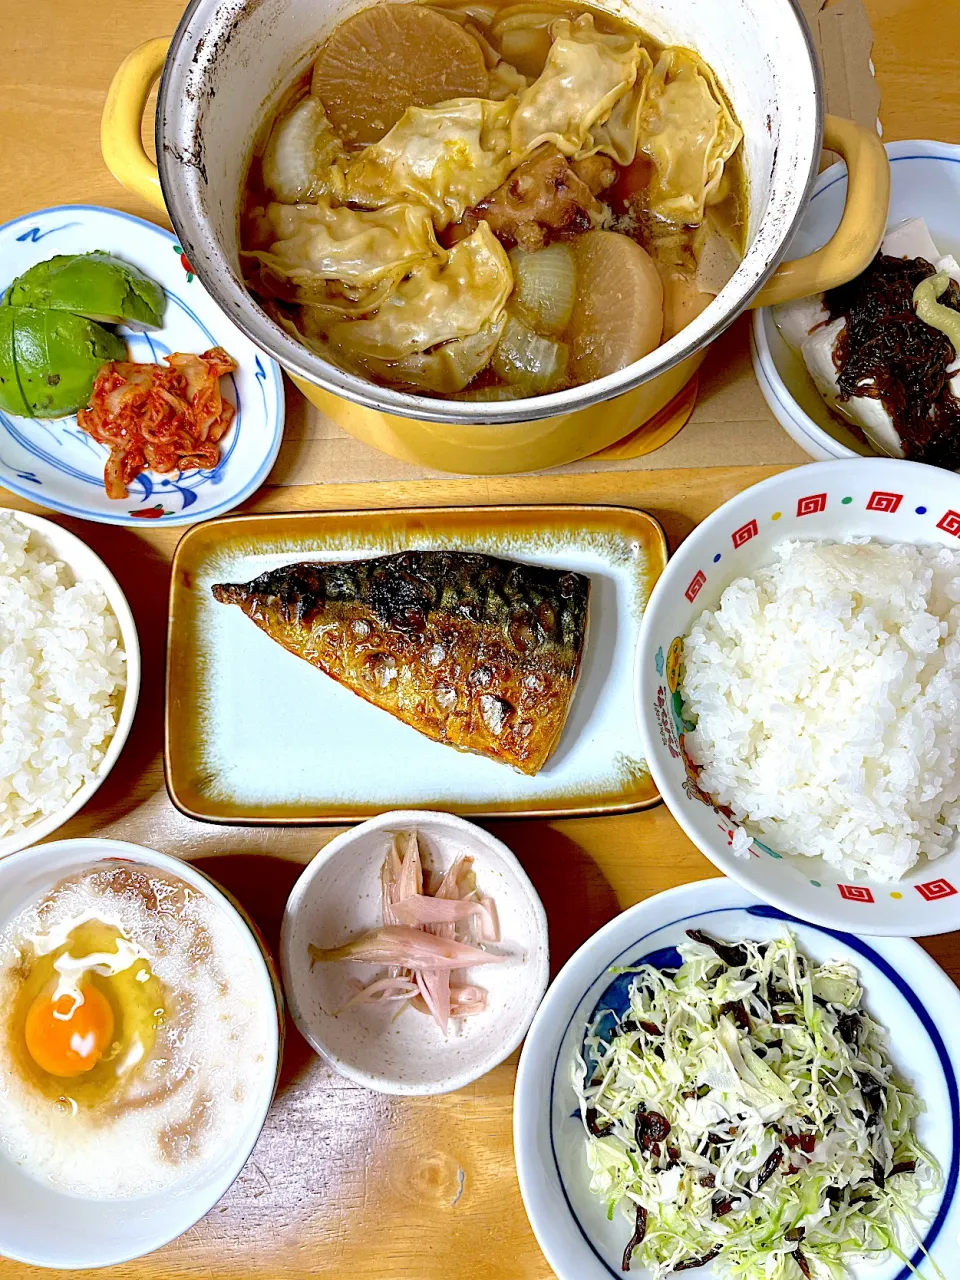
[280,809,549,1094]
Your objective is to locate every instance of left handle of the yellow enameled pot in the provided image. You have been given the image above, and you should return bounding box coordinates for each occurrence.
[100,36,170,212]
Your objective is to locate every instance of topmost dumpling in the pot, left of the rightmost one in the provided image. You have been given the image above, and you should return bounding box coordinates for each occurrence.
[511,14,649,163]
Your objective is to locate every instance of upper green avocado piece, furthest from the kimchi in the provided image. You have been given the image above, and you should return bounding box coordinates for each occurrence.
[4,250,166,325]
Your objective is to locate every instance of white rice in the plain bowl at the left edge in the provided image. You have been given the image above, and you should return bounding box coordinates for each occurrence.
[0,512,127,838]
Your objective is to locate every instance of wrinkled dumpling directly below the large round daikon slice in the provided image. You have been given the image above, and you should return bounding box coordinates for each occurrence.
[347,97,517,230]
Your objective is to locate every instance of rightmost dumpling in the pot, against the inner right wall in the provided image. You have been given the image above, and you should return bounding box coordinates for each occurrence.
[640,49,742,227]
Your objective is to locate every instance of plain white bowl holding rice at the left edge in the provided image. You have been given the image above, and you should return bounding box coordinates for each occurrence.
[0,508,140,858]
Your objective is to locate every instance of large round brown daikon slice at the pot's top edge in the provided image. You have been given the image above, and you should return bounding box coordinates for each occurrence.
[312,4,488,145]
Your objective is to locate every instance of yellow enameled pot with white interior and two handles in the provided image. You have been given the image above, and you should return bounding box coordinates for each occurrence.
[101,0,890,475]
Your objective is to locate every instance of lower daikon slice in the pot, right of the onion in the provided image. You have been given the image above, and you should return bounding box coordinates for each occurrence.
[567,230,663,383]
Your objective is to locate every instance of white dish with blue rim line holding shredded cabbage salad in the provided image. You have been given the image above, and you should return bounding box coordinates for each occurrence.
[513,879,960,1280]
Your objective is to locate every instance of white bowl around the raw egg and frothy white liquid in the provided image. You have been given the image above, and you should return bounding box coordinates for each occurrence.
[0,840,283,1270]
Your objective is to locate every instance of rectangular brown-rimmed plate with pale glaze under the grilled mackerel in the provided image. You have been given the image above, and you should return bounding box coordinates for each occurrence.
[164,506,667,824]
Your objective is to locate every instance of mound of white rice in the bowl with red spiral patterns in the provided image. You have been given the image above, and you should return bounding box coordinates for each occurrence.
[682,539,960,881]
